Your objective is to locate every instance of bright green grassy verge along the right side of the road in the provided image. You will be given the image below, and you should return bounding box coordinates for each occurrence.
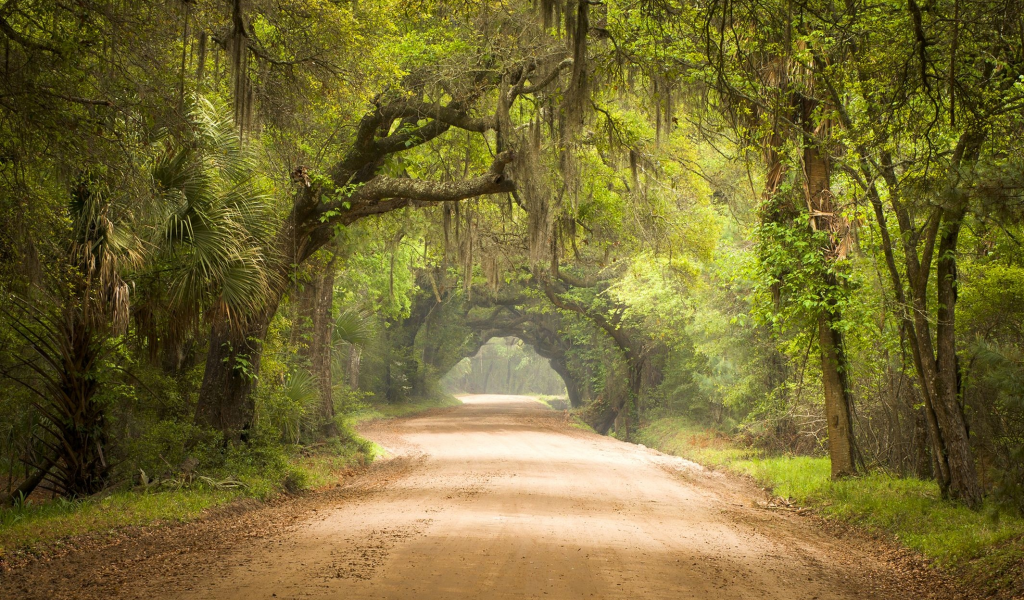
[637,417,1024,598]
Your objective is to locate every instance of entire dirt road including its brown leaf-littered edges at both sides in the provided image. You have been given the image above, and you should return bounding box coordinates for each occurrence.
[0,395,968,600]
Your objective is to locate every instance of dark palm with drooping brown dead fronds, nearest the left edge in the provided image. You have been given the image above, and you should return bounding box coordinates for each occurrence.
[2,179,146,500]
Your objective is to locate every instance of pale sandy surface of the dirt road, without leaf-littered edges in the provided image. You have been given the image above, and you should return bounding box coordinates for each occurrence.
[174,395,950,600]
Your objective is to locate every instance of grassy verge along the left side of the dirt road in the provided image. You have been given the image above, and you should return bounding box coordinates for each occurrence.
[0,396,460,556]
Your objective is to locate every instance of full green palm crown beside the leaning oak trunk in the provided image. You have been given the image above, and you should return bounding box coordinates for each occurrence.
[153,97,273,327]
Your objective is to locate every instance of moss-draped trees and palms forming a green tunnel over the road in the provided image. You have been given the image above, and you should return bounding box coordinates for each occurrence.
[0,0,1024,518]
